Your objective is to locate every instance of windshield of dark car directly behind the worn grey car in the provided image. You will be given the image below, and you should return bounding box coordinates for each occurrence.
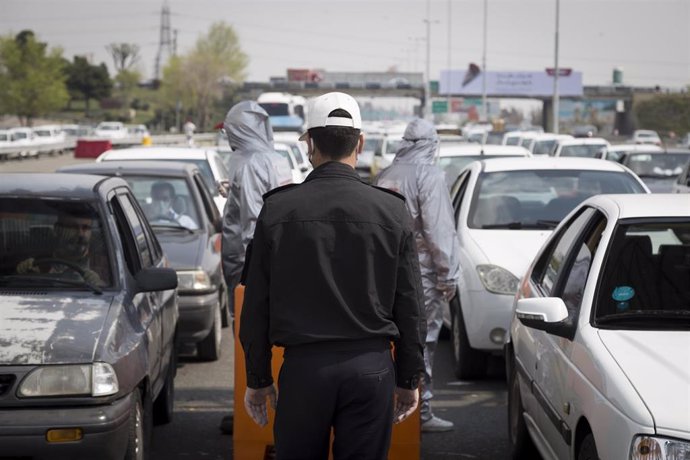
[124,176,199,230]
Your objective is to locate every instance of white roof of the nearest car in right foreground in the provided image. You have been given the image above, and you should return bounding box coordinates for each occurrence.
[585,193,690,219]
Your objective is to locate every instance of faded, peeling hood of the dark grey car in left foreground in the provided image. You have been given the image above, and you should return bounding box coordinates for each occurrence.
[0,295,112,365]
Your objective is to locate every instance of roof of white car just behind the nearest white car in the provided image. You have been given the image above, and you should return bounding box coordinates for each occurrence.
[481,157,628,172]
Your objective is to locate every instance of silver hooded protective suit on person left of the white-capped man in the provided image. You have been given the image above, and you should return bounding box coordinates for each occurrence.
[222,101,278,290]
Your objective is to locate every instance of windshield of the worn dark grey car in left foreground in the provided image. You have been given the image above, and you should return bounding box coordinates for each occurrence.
[0,198,112,290]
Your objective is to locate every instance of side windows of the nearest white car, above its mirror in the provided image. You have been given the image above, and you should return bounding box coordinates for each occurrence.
[532,208,596,297]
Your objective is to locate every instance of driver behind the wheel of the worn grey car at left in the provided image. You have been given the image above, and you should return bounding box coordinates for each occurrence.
[16,214,104,286]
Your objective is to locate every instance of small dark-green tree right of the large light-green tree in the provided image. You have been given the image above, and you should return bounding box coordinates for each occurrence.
[67,56,113,116]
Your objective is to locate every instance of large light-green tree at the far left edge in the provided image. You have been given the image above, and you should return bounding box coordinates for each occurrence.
[0,30,69,126]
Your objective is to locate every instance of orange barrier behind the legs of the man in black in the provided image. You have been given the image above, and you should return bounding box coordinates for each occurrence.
[233,285,421,460]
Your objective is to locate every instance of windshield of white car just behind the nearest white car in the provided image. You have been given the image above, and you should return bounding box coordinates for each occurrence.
[467,170,645,230]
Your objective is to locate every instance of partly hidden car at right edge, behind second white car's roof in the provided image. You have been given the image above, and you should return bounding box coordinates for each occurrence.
[621,149,690,193]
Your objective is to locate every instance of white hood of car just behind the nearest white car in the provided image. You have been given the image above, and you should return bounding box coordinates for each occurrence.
[468,229,551,278]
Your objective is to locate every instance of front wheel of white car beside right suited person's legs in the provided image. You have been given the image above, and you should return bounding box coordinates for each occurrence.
[450,296,486,380]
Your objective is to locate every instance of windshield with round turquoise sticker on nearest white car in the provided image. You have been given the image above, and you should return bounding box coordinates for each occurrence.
[594,221,690,330]
